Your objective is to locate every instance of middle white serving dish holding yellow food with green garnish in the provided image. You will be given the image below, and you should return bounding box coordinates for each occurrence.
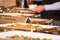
[0,23,58,32]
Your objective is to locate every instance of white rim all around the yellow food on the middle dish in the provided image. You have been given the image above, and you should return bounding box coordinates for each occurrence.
[0,23,59,31]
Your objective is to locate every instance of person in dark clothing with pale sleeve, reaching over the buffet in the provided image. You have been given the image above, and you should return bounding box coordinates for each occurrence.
[33,2,60,26]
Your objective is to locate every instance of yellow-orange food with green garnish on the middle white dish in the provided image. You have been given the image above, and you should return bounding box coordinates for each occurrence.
[11,24,43,30]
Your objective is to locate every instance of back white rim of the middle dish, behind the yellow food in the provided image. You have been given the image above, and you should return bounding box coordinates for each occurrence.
[0,23,59,29]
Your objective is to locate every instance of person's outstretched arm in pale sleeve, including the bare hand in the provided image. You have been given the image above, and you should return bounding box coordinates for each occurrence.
[33,2,60,12]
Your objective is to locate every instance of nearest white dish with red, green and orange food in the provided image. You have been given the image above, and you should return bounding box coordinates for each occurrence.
[0,30,60,40]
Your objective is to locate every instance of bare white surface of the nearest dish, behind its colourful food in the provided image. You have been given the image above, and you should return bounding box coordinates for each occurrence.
[0,31,60,40]
